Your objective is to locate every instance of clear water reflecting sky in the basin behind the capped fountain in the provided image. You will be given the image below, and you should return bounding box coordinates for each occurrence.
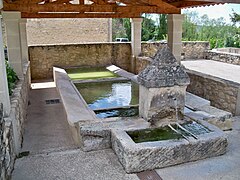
[75,81,139,118]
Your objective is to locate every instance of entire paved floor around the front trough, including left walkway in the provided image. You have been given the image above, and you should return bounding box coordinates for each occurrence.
[12,85,240,180]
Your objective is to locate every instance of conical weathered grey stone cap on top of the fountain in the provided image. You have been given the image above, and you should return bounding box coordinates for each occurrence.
[138,47,190,88]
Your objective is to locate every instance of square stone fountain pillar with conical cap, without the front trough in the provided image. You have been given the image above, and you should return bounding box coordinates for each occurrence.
[138,47,190,126]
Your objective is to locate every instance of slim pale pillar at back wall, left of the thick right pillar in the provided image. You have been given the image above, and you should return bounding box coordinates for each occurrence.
[130,18,142,57]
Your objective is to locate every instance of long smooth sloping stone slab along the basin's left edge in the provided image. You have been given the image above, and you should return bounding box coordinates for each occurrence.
[53,67,97,126]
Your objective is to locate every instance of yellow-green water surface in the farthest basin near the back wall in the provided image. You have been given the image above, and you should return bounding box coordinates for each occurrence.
[66,68,118,80]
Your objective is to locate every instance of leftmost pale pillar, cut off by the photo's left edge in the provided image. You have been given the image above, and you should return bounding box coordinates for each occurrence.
[0,18,10,117]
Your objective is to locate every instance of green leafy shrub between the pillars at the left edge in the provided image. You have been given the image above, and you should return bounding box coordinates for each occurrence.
[5,61,18,95]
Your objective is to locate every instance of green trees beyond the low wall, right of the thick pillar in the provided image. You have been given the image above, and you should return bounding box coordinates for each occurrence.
[183,12,240,48]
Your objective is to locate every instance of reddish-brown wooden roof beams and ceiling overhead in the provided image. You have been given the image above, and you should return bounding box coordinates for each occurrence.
[3,0,240,18]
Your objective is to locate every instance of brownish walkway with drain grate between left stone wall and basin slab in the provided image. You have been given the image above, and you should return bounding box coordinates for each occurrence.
[22,88,76,154]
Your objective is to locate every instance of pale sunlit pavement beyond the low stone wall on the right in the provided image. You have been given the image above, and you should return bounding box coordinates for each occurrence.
[181,60,240,83]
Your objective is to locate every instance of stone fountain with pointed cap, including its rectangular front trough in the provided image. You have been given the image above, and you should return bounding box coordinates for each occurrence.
[111,47,227,173]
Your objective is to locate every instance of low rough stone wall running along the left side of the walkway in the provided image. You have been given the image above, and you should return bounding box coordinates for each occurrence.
[0,64,30,180]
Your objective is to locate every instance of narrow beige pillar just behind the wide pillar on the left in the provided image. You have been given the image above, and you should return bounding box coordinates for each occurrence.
[19,18,29,64]
